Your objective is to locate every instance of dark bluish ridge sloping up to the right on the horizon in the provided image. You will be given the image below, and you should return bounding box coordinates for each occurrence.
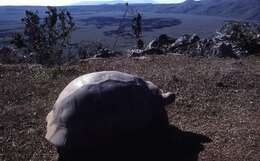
[158,0,260,21]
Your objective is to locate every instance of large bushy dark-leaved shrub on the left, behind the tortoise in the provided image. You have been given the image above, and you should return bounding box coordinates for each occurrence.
[12,7,75,65]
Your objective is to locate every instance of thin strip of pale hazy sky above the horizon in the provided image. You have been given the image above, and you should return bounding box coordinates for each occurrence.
[0,0,185,6]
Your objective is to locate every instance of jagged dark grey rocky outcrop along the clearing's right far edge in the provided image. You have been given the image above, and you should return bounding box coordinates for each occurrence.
[130,22,260,58]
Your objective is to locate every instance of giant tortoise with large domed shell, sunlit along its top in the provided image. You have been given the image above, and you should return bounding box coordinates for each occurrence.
[46,71,175,160]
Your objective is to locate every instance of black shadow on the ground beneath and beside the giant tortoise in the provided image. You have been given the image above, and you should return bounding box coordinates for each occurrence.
[58,126,212,161]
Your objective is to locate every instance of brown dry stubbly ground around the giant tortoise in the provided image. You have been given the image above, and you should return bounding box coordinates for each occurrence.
[0,55,260,161]
